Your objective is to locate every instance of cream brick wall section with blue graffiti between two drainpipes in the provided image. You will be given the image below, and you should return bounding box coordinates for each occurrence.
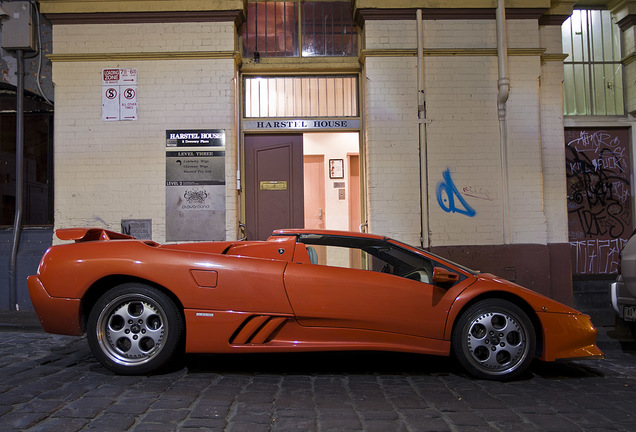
[425,56,503,245]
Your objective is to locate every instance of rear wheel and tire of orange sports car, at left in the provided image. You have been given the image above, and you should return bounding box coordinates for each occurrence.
[87,283,185,375]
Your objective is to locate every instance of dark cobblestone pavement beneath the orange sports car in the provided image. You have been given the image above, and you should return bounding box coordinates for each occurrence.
[0,331,636,432]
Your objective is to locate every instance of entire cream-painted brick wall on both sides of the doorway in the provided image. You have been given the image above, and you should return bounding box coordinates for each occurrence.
[48,13,567,255]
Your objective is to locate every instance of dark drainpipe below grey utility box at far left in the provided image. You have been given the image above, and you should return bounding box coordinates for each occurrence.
[9,50,24,311]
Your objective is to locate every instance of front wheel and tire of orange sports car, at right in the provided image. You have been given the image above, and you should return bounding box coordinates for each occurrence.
[451,299,537,381]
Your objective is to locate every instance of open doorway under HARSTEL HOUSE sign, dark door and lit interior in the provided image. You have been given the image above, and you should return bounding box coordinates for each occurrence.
[244,132,360,240]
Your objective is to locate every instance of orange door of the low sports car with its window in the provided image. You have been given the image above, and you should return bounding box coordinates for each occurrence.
[284,238,448,339]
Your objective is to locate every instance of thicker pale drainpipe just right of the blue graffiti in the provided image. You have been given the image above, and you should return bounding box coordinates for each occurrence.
[496,0,511,244]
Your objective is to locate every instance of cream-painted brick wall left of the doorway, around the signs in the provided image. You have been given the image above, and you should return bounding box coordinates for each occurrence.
[53,23,238,242]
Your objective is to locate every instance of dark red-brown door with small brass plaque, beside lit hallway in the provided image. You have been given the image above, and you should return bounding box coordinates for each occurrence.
[245,135,304,240]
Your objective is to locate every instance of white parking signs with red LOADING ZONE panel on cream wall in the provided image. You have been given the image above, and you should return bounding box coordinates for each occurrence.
[102,68,137,121]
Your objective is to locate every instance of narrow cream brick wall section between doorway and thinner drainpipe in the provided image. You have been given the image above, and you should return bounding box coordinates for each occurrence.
[365,57,421,244]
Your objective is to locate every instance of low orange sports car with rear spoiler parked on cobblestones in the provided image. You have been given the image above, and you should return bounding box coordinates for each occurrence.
[28,228,603,380]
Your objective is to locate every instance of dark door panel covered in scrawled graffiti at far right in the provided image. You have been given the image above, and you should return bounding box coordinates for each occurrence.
[565,128,633,274]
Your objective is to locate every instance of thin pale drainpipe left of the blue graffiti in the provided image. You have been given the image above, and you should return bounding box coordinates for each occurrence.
[416,9,430,248]
